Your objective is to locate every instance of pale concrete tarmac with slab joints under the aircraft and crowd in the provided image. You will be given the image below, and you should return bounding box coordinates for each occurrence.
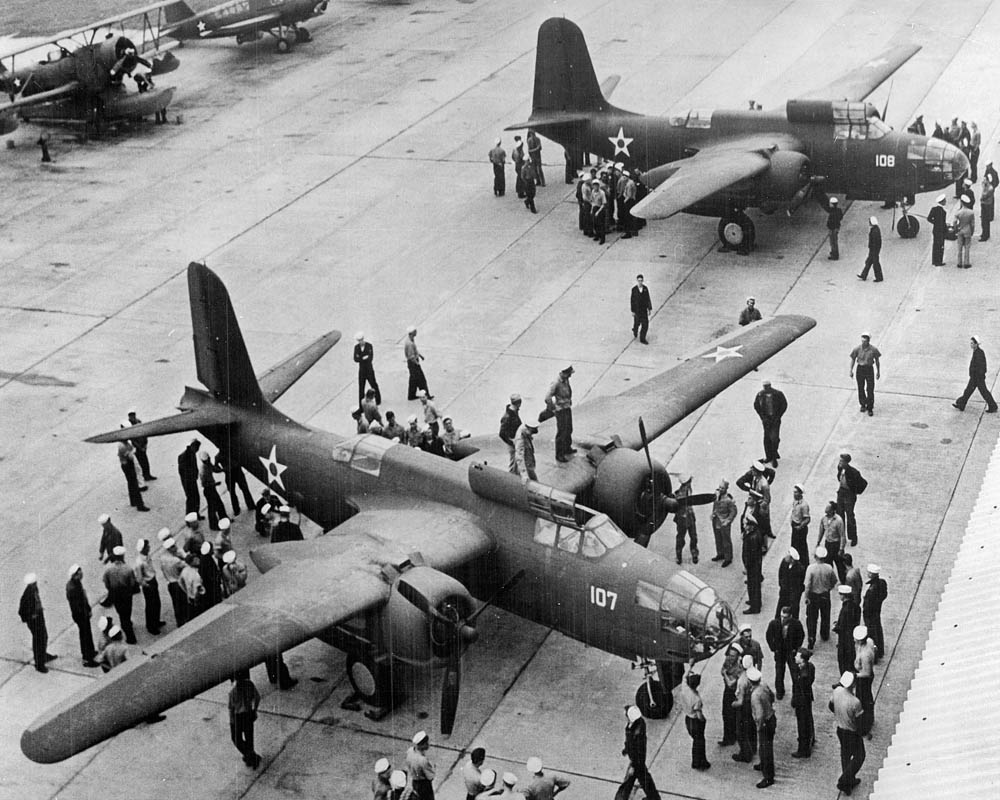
[0,0,1000,800]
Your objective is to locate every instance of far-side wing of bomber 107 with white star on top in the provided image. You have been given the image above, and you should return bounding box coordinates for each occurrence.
[561,315,816,456]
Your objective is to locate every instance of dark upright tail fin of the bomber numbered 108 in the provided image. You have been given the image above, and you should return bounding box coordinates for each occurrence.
[531,17,611,119]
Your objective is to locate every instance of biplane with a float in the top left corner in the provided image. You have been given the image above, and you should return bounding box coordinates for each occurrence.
[0,0,178,134]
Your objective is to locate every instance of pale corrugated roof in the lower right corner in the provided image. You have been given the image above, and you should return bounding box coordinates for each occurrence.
[870,440,1000,800]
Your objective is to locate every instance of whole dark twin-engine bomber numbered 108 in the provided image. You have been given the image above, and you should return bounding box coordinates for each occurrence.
[507,18,969,252]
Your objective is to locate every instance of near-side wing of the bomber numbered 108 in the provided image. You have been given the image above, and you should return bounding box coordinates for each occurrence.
[632,145,771,219]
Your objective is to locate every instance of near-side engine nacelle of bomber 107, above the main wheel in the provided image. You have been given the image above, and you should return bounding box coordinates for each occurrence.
[381,566,475,664]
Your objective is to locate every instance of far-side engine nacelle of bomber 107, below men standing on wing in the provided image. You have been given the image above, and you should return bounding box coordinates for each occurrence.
[594,448,671,544]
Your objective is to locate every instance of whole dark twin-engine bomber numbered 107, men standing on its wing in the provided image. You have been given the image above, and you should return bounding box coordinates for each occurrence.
[21,264,815,763]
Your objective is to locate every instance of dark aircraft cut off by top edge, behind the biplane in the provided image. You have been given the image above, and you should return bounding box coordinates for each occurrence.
[166,0,328,53]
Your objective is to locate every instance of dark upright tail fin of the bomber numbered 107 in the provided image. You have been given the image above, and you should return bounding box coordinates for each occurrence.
[188,262,263,408]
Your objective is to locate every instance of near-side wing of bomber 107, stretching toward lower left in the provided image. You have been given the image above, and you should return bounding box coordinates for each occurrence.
[21,506,493,764]
